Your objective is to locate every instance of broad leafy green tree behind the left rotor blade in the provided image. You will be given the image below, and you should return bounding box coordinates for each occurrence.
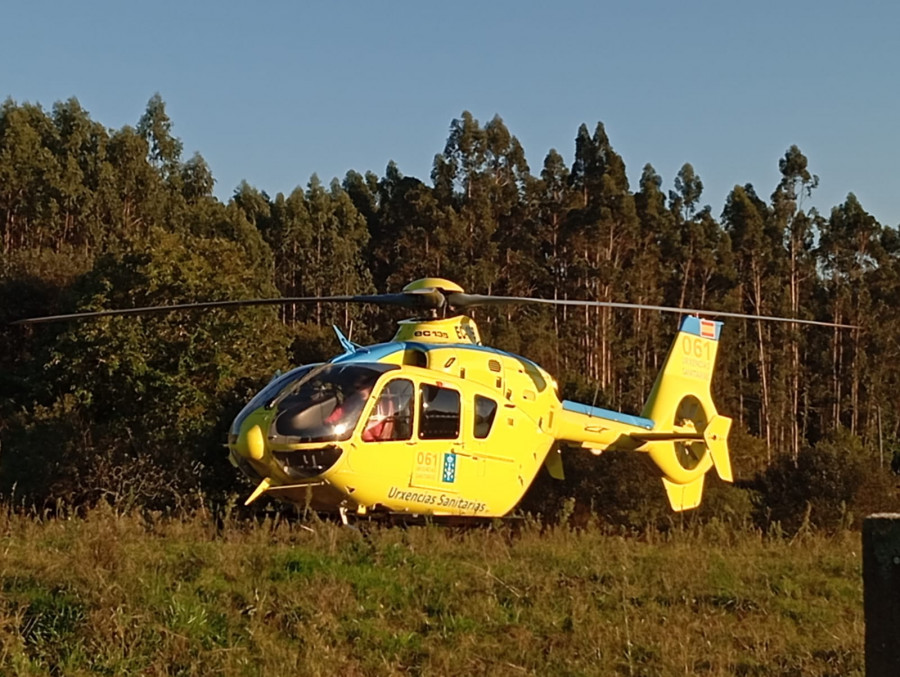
[2,229,286,505]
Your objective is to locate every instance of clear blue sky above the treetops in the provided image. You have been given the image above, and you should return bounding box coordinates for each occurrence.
[7,0,900,226]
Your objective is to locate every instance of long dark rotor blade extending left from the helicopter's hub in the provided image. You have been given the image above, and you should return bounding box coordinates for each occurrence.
[10,289,446,324]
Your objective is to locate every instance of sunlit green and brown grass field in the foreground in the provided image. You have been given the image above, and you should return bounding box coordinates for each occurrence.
[0,508,863,677]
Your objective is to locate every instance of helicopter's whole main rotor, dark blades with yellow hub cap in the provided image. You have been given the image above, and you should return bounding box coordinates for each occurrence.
[10,277,856,329]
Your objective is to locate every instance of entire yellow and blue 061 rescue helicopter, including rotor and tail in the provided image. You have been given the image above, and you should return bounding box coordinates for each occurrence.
[13,277,847,523]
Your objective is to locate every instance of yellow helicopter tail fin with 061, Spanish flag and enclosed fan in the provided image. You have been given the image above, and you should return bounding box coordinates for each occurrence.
[632,317,733,510]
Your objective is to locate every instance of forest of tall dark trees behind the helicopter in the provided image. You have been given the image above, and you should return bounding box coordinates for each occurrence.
[0,94,900,528]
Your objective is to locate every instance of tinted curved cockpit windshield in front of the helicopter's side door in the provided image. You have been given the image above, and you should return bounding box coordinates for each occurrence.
[272,364,397,442]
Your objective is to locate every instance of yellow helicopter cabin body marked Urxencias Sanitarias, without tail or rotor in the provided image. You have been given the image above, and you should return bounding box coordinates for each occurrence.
[230,318,562,517]
